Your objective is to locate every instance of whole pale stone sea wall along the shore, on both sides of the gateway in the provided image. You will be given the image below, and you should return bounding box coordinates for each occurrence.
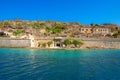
[0,38,120,49]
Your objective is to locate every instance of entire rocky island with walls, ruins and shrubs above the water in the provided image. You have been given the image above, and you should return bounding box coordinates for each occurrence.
[0,19,120,49]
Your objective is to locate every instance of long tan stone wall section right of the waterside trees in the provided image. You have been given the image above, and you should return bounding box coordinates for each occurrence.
[81,39,120,49]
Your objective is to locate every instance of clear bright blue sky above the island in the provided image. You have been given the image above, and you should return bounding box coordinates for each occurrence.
[0,0,120,25]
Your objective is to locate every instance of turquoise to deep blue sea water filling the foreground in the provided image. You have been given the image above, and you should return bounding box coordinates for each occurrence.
[0,48,120,80]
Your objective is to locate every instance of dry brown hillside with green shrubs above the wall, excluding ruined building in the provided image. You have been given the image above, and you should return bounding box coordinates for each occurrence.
[0,19,120,37]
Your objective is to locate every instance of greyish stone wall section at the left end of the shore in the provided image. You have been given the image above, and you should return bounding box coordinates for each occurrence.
[0,39,31,48]
